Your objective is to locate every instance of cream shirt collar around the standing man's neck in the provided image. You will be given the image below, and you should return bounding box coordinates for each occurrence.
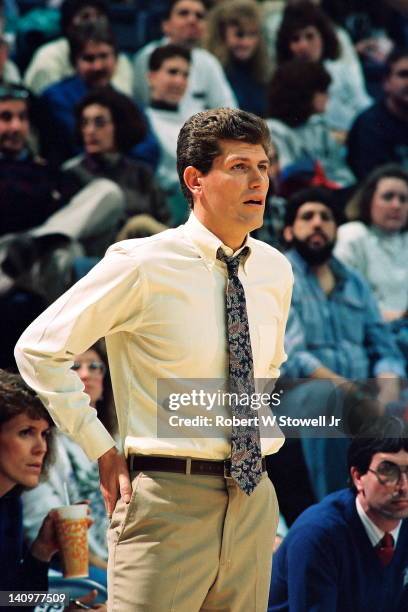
[184,211,251,274]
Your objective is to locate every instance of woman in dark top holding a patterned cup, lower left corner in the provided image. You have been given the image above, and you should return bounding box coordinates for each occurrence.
[0,370,58,591]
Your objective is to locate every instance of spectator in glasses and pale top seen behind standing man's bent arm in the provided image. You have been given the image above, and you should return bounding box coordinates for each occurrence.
[22,344,118,585]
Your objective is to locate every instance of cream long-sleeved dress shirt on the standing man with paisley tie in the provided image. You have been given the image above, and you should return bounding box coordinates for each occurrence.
[15,214,293,460]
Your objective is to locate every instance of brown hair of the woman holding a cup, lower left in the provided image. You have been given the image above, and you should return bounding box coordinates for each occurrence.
[0,369,54,477]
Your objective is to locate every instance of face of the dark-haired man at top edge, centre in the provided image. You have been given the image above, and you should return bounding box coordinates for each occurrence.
[162,0,206,47]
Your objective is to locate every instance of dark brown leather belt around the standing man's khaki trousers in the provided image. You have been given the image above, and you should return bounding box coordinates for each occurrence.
[128,455,266,478]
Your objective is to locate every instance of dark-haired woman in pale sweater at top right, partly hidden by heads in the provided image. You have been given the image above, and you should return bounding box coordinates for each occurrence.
[277,0,370,132]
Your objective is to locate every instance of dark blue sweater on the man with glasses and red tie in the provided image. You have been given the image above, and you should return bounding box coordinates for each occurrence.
[268,489,408,612]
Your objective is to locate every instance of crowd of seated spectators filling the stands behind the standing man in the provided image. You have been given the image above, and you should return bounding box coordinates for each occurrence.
[0,0,408,612]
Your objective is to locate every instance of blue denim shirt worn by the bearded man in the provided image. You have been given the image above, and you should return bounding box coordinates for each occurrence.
[283,250,404,379]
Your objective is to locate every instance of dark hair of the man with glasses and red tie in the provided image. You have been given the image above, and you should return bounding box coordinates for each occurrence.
[347,417,408,474]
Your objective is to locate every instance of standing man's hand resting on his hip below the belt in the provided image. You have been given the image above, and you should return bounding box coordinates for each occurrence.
[98,447,132,517]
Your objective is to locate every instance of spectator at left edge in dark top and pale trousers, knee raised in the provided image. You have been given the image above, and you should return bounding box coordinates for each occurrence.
[0,86,124,367]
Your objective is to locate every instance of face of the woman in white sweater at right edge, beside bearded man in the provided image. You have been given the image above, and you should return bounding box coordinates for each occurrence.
[371,177,408,232]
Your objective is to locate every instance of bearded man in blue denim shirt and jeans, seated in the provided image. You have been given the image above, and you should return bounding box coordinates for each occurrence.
[270,188,404,506]
